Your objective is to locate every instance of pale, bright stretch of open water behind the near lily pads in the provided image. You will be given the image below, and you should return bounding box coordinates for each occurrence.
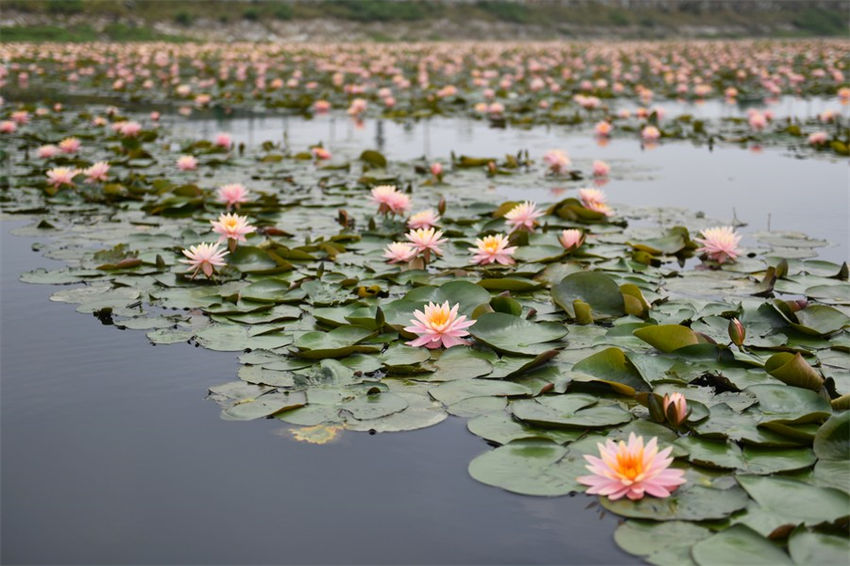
[174,113,850,263]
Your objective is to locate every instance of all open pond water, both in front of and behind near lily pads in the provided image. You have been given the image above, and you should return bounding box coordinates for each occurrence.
[0,112,850,564]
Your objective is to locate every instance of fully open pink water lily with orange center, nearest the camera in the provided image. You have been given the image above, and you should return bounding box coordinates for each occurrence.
[577,433,685,501]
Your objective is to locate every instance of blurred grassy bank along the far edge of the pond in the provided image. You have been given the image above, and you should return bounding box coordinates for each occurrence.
[0,0,848,41]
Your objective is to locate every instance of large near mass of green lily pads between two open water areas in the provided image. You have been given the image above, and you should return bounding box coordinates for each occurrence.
[0,97,850,564]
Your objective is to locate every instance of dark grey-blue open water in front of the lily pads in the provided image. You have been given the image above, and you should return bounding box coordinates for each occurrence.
[0,218,636,564]
